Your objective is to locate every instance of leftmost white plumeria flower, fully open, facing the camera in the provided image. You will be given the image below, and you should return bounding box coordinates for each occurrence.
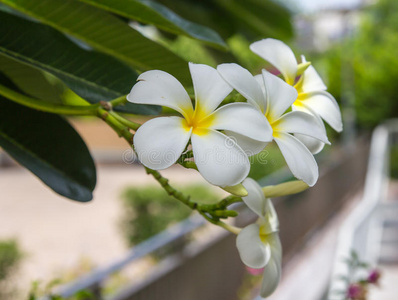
[127,63,272,187]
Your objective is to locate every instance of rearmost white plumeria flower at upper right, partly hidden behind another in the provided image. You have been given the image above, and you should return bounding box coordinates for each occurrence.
[250,39,343,154]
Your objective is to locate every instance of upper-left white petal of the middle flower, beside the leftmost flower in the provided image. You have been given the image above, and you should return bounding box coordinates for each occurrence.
[217,64,266,113]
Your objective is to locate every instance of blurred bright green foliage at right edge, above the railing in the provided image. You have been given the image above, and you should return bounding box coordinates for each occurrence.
[324,0,398,128]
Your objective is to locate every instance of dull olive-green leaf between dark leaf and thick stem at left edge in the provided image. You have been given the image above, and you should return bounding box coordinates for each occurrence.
[0,54,64,103]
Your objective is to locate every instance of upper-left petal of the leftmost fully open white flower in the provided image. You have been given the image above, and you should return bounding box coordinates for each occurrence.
[127,70,193,117]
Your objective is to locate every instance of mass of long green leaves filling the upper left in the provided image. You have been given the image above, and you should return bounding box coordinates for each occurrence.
[0,0,293,201]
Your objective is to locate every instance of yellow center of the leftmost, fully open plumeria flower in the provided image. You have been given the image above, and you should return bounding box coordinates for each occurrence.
[183,101,214,135]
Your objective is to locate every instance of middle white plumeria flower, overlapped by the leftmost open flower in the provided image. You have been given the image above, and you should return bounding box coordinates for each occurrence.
[217,64,329,186]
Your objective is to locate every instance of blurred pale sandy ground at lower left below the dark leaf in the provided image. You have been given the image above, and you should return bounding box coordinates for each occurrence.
[0,165,210,294]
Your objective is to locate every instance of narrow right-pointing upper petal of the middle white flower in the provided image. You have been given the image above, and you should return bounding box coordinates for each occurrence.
[272,111,330,144]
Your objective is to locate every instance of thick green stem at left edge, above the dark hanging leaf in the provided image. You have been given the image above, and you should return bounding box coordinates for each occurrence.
[0,84,99,116]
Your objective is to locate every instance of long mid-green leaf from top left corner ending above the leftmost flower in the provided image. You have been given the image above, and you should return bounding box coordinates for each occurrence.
[0,0,191,84]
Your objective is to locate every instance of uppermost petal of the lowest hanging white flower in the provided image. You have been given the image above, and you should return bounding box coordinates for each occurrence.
[242,178,266,218]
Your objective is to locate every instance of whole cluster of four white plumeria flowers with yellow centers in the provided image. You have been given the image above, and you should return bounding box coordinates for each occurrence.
[127,39,342,297]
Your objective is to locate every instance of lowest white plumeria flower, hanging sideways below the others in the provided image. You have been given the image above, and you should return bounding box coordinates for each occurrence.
[236,178,282,297]
